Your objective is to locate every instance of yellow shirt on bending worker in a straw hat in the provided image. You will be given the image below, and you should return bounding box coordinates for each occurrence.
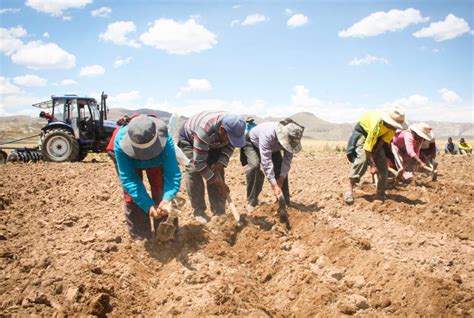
[359,111,395,152]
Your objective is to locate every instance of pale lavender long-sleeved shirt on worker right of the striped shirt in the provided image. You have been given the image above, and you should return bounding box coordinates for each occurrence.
[249,122,293,185]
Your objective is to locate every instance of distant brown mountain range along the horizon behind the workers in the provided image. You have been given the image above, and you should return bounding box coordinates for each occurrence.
[0,108,474,142]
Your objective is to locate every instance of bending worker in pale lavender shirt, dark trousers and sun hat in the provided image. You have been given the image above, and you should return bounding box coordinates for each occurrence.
[241,118,304,212]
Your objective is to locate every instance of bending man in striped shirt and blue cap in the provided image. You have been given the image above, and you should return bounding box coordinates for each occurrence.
[178,111,245,224]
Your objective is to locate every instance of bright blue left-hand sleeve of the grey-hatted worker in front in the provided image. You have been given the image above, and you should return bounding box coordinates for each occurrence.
[115,147,154,213]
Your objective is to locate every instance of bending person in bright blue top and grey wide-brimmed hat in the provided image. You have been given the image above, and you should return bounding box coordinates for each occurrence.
[114,115,181,240]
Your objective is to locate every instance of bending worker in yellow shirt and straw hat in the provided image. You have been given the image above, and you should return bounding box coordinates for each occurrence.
[344,107,407,204]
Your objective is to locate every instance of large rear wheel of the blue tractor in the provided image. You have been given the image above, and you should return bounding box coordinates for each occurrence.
[40,128,79,162]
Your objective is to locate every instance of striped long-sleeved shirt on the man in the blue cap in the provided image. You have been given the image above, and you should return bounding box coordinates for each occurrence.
[184,111,234,181]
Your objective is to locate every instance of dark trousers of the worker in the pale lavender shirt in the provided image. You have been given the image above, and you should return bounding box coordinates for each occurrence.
[240,140,290,206]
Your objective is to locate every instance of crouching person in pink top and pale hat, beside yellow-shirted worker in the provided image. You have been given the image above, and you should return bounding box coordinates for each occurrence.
[392,123,434,182]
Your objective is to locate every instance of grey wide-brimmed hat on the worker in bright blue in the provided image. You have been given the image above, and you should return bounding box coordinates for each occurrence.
[119,115,168,160]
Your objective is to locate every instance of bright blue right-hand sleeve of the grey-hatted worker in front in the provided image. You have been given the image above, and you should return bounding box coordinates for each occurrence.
[160,135,181,201]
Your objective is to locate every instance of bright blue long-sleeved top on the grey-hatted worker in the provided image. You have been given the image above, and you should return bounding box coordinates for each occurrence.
[114,126,181,213]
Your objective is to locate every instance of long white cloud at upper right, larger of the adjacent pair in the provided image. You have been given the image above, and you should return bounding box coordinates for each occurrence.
[339,8,429,38]
